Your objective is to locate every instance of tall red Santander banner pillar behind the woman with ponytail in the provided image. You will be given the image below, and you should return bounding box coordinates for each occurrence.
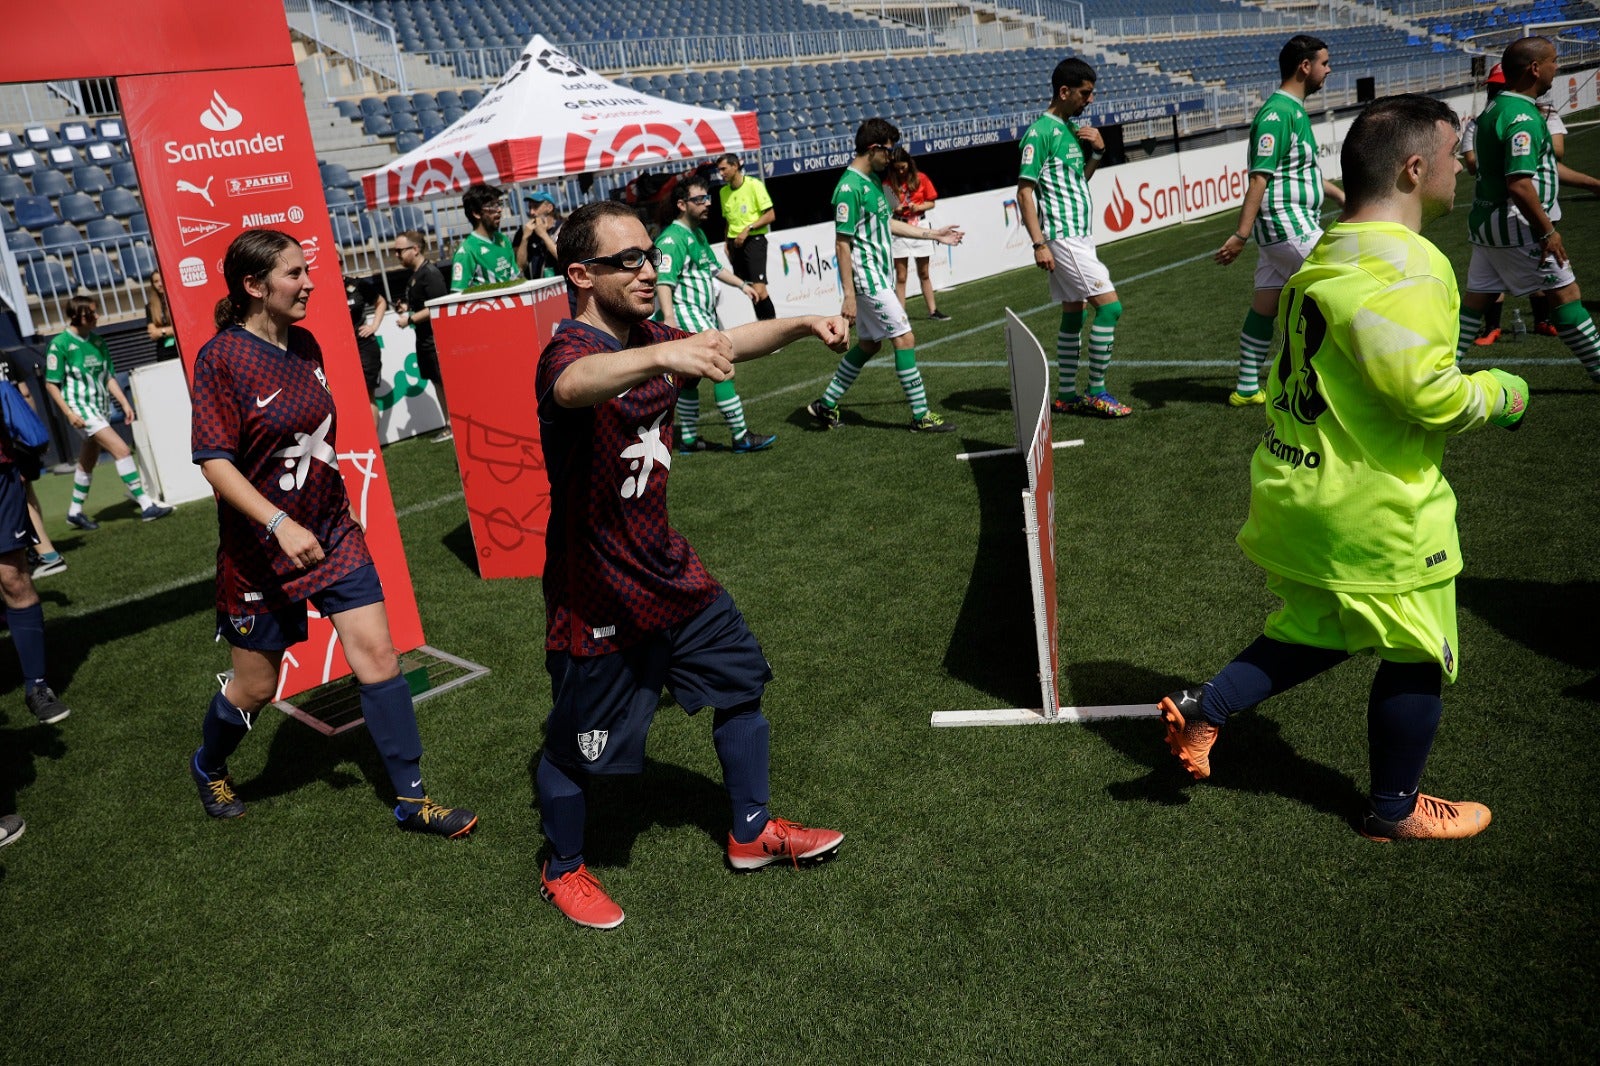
[118,66,422,698]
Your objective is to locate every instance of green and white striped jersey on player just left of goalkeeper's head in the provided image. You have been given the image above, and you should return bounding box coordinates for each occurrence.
[1250,90,1322,245]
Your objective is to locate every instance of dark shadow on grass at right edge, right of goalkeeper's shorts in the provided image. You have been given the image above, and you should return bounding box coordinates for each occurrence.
[1456,575,1600,703]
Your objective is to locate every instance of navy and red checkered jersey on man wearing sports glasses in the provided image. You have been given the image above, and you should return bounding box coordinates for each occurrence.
[536,320,722,658]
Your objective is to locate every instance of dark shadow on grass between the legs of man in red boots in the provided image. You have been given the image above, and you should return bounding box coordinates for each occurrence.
[528,745,728,866]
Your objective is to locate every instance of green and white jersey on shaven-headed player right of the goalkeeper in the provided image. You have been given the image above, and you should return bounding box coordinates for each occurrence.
[1467,93,1562,248]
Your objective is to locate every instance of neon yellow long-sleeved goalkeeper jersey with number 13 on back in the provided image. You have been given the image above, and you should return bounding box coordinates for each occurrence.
[1238,222,1502,592]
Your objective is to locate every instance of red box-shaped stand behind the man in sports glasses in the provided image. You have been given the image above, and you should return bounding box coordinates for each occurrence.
[429,279,568,578]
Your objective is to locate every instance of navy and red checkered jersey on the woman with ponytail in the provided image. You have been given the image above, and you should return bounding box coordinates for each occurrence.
[190,327,373,615]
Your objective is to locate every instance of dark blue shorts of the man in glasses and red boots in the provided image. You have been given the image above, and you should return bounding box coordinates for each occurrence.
[544,589,773,773]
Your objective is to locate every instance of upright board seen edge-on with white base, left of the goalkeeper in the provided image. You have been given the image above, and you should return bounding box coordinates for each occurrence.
[933,307,1157,725]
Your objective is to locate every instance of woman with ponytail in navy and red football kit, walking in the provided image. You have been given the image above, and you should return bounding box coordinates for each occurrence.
[189,229,478,837]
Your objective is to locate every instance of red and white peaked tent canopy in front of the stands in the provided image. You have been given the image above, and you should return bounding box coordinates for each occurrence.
[362,37,760,208]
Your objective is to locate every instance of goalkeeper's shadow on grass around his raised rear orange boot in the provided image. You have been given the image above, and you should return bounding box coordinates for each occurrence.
[1067,663,1366,826]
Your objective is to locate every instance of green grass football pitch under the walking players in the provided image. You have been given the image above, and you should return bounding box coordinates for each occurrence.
[9,120,1600,1063]
